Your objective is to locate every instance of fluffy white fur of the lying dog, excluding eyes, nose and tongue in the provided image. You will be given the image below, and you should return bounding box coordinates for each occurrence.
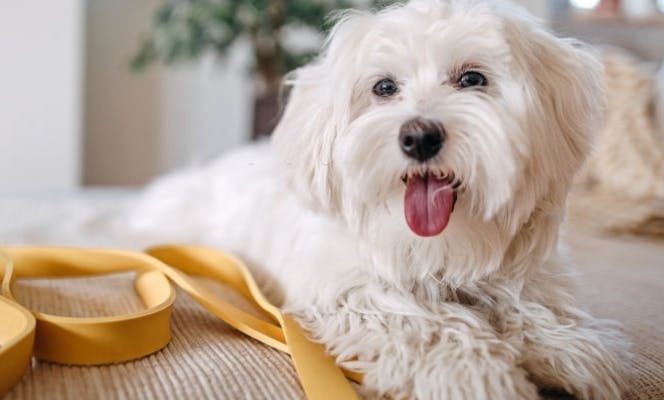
[126,0,628,399]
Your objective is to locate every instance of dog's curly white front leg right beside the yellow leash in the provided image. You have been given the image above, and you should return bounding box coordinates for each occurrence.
[293,285,538,400]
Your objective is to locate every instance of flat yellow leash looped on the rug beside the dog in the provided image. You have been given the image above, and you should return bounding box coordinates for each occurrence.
[0,246,361,400]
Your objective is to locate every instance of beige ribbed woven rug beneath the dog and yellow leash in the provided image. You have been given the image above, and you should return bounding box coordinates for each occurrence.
[6,230,664,400]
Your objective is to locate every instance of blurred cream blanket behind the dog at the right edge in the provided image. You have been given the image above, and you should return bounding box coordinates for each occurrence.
[570,52,664,235]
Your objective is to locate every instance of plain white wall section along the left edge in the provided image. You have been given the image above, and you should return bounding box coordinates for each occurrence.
[0,0,84,193]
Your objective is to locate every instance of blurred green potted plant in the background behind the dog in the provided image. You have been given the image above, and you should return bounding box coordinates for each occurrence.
[132,0,384,138]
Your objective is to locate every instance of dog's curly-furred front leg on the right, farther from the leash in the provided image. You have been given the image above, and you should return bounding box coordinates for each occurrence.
[517,262,630,400]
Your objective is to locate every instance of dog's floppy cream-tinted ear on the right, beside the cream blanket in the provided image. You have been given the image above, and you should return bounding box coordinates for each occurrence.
[503,17,605,274]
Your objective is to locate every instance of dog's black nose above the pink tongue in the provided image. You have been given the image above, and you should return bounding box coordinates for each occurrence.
[399,118,445,162]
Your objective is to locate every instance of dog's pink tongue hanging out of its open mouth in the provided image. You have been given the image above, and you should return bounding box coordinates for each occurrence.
[404,175,454,236]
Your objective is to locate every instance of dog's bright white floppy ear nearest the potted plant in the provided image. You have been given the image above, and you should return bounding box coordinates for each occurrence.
[273,12,371,212]
